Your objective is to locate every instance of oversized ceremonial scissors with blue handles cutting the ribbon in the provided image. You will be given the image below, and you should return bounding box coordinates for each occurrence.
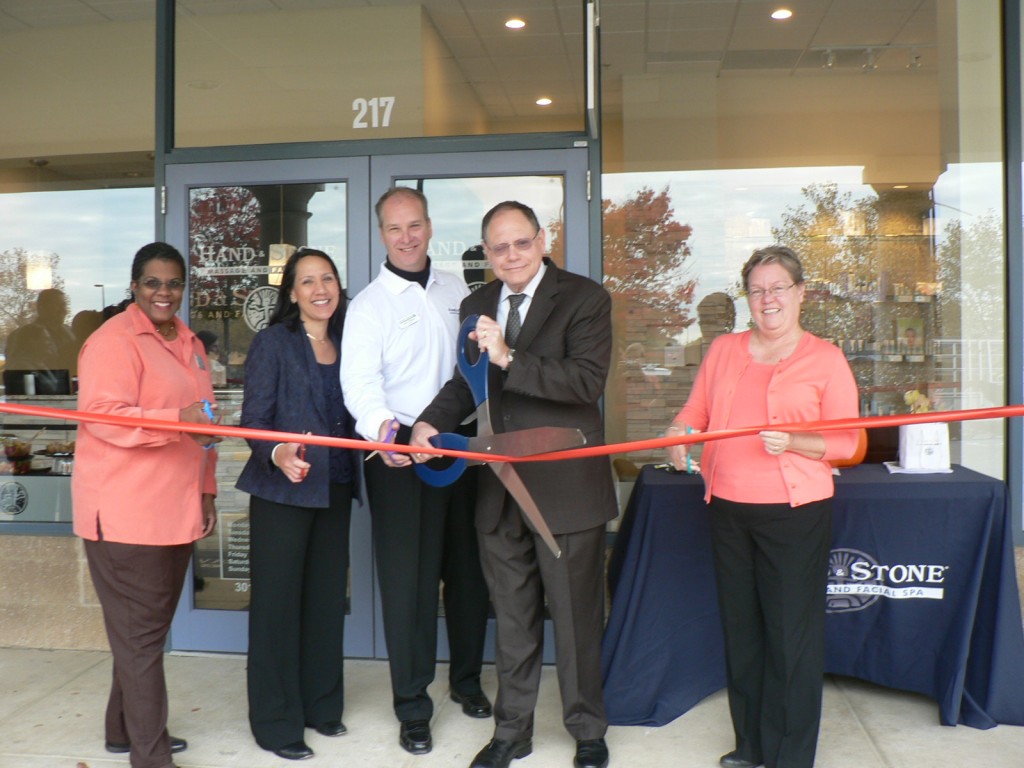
[416,314,587,557]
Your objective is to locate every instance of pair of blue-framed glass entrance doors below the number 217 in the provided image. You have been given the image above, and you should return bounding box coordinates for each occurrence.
[166,148,589,659]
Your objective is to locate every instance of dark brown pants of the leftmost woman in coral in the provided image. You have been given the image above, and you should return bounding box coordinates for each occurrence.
[85,540,193,768]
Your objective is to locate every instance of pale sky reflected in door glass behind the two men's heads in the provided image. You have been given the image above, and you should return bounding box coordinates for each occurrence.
[398,176,564,262]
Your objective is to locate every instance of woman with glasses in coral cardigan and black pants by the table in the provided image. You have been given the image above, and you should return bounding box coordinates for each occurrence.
[667,246,857,768]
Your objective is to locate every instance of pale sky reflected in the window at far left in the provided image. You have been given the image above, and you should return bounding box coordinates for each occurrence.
[0,187,155,315]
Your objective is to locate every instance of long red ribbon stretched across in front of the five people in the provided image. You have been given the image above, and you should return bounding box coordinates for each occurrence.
[0,402,1024,462]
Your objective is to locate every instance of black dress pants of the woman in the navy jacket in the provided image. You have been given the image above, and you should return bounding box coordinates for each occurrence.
[247,483,352,750]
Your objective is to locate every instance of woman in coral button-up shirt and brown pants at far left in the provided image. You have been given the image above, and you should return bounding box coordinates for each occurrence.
[72,243,220,768]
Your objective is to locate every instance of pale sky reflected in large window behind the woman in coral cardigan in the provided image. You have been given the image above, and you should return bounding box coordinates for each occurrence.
[601,163,1001,342]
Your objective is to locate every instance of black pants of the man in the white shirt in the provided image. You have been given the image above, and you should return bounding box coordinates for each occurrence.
[366,442,489,721]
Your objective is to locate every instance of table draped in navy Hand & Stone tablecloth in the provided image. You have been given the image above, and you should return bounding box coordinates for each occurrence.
[602,464,1024,728]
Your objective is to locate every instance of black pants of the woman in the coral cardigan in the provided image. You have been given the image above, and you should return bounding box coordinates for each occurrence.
[711,499,831,768]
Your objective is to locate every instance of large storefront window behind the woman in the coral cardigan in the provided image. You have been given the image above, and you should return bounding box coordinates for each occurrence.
[602,0,1006,476]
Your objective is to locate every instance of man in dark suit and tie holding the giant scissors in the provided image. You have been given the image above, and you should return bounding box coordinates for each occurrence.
[411,201,616,768]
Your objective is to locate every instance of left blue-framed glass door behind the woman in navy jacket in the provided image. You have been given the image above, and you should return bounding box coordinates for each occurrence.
[167,158,373,656]
